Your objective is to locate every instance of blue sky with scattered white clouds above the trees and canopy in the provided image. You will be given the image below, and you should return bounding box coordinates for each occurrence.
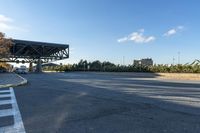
[0,0,200,65]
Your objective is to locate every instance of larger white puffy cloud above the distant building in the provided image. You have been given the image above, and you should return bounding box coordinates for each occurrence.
[117,29,156,43]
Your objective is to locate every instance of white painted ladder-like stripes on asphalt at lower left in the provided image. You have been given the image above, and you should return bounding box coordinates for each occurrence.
[0,87,26,133]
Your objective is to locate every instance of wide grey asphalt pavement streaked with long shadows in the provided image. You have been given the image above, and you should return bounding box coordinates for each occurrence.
[14,72,200,133]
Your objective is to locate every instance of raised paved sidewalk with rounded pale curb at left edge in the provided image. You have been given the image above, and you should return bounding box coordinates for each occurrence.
[0,73,27,88]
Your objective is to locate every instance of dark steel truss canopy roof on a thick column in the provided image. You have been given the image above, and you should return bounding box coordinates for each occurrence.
[7,39,69,72]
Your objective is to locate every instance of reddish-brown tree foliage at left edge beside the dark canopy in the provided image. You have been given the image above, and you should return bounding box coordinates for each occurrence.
[0,32,13,60]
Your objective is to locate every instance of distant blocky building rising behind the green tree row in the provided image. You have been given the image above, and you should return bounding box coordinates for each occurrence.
[133,58,153,66]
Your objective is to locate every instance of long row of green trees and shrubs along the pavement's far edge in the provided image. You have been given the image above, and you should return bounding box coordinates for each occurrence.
[43,60,200,73]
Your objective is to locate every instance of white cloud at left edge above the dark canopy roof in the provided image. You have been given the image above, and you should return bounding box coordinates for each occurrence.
[0,14,27,32]
